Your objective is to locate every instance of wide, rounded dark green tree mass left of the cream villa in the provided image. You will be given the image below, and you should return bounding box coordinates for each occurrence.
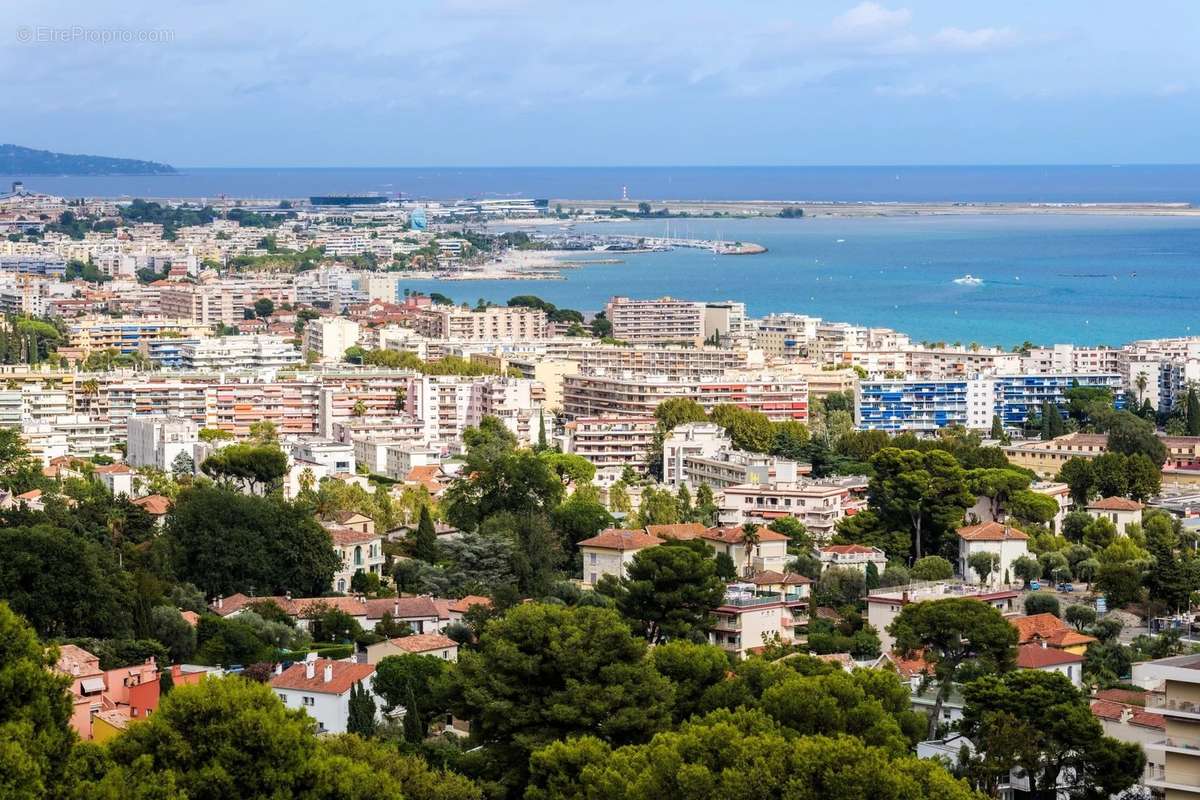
[166,486,341,596]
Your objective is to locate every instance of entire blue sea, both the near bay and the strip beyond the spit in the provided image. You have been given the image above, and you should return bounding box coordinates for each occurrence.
[7,166,1200,347]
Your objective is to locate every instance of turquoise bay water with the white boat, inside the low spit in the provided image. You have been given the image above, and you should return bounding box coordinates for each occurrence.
[402,215,1200,347]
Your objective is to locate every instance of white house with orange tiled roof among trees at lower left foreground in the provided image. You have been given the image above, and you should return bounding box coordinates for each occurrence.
[271,654,382,733]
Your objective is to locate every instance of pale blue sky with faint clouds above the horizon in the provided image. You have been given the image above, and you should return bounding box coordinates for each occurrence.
[0,0,1200,167]
